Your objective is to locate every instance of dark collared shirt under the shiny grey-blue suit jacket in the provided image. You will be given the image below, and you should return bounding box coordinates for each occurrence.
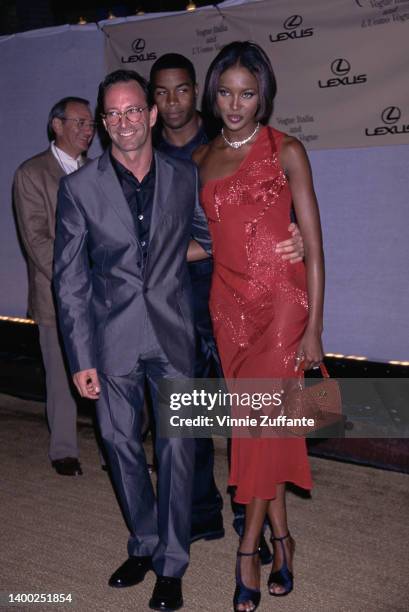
[111,153,155,258]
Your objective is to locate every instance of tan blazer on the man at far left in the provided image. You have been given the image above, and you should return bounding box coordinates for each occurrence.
[13,149,64,325]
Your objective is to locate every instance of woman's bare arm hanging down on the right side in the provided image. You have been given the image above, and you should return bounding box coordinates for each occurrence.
[280,136,324,370]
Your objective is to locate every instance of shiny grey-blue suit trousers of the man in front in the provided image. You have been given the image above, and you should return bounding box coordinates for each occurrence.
[97,340,195,577]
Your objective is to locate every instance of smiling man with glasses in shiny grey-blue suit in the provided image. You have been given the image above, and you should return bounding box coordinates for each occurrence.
[54,70,210,610]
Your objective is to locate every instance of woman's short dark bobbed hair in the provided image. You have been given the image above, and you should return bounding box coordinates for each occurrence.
[204,40,277,123]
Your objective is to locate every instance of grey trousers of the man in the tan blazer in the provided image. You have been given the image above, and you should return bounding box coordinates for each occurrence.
[38,325,78,461]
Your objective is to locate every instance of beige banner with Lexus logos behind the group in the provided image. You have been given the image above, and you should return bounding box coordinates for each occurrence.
[103,0,409,149]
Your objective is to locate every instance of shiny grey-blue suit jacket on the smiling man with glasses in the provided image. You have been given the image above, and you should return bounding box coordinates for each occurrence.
[54,151,211,376]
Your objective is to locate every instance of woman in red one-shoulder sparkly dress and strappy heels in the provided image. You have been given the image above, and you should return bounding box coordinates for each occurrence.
[194,42,324,611]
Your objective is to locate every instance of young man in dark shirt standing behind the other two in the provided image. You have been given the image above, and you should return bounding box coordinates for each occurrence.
[150,53,224,542]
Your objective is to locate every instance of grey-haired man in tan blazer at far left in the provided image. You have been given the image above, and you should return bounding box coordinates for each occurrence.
[14,97,95,476]
